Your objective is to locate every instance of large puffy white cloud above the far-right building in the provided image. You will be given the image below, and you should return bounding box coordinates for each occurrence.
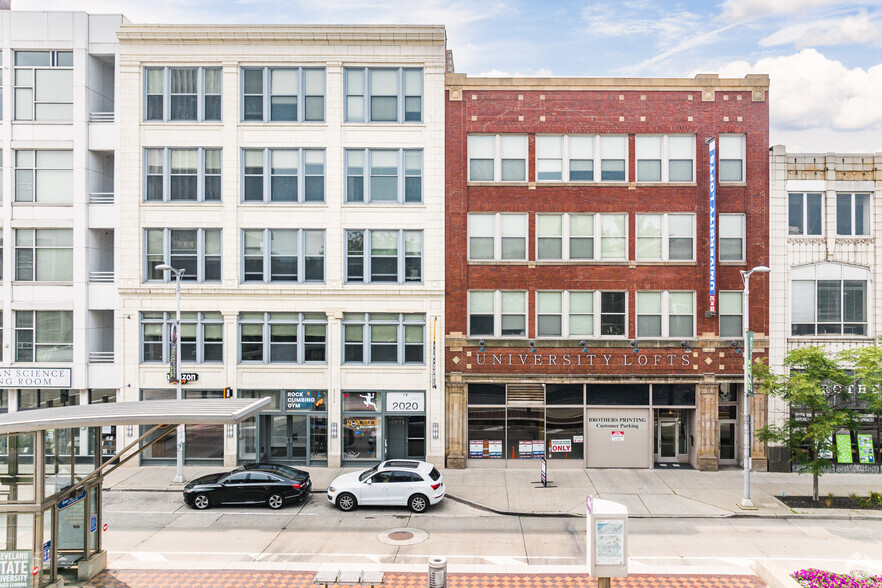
[719,49,882,132]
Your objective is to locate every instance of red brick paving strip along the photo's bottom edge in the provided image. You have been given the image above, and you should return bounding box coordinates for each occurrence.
[86,570,765,588]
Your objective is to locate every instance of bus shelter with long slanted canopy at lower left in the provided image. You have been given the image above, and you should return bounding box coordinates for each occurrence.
[0,398,270,588]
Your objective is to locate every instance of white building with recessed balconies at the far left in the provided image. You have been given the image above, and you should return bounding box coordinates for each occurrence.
[0,10,127,455]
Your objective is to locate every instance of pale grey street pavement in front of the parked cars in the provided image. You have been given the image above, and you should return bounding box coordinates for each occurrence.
[104,491,882,574]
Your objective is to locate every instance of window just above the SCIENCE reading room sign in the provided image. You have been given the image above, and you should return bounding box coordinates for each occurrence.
[15,310,73,363]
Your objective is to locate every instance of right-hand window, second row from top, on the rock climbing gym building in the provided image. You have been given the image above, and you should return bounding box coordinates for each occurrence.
[346,149,423,204]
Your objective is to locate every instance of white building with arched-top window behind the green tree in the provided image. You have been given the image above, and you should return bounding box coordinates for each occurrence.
[769,145,882,471]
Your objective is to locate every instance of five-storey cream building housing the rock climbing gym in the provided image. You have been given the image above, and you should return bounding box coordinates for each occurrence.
[116,25,446,467]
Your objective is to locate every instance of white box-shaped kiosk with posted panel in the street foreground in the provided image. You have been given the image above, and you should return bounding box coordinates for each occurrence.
[586,496,628,585]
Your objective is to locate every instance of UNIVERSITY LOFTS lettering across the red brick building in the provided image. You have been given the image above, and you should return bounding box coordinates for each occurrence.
[476,352,692,367]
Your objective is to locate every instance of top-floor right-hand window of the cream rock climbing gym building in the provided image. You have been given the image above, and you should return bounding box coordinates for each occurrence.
[343,67,423,122]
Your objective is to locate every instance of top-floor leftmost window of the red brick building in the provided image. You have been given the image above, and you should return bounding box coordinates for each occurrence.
[468,135,527,182]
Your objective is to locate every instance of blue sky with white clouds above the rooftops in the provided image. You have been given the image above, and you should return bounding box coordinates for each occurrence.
[12,0,882,152]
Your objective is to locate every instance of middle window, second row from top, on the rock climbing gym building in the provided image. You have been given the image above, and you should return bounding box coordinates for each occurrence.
[242,149,325,202]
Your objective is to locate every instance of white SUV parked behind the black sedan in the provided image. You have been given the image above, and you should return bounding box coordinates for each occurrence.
[328,459,444,512]
